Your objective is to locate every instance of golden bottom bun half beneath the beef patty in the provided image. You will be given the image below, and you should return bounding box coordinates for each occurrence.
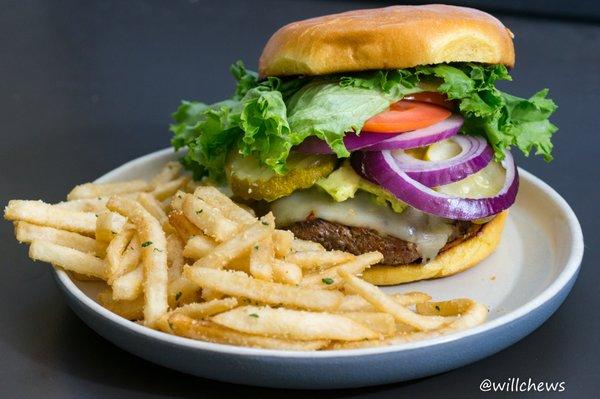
[363,210,508,285]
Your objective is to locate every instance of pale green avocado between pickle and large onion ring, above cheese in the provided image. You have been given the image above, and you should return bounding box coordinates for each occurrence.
[316,161,408,213]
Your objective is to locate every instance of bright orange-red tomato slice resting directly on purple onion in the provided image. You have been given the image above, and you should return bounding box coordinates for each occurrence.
[362,100,452,133]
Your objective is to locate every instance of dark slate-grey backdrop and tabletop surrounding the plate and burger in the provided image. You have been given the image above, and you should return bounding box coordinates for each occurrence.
[0,0,600,398]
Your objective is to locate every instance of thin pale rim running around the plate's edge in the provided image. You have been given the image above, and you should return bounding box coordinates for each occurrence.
[53,148,584,359]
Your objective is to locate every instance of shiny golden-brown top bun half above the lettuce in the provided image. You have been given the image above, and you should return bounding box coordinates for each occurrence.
[259,4,515,76]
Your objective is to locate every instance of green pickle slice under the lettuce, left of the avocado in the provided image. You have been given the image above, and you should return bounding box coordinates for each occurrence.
[225,152,336,201]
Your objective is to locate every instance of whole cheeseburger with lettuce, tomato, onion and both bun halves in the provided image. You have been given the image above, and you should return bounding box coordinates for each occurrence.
[171,5,557,285]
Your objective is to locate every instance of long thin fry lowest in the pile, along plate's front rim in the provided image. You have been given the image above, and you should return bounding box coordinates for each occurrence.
[169,314,329,351]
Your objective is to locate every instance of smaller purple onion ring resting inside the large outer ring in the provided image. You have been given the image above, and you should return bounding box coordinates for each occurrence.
[392,135,494,187]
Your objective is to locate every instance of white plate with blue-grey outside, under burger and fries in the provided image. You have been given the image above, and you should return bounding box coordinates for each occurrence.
[56,149,583,389]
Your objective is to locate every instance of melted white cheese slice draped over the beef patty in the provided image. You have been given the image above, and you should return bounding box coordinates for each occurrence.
[271,188,452,261]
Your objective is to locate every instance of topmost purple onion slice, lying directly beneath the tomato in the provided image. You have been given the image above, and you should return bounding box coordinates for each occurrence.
[294,114,463,154]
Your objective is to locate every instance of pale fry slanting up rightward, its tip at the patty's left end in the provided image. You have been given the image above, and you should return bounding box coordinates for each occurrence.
[191,219,273,268]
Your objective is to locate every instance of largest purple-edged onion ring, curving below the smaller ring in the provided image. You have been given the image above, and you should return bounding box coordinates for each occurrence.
[352,151,519,220]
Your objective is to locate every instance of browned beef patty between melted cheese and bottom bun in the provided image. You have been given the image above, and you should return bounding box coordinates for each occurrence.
[286,218,483,265]
